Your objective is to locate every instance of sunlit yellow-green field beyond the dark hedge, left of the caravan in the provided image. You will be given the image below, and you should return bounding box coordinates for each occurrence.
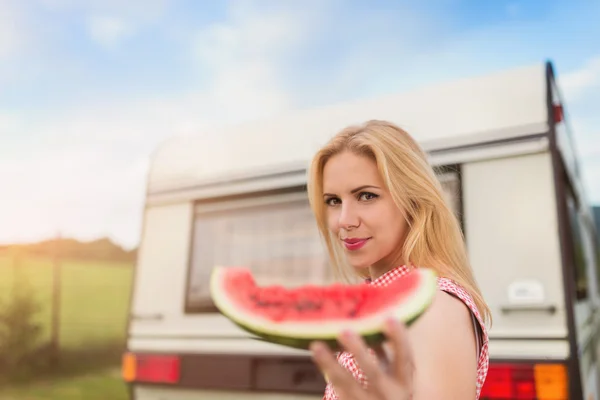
[0,256,133,349]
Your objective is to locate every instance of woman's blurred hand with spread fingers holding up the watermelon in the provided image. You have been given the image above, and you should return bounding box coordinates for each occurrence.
[311,321,414,400]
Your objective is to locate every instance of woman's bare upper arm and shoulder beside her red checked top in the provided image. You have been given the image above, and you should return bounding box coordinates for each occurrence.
[408,291,478,400]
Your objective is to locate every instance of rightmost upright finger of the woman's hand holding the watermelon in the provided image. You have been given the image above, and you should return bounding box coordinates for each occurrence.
[385,320,414,388]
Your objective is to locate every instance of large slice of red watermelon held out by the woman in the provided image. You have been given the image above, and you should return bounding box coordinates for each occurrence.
[210,267,437,349]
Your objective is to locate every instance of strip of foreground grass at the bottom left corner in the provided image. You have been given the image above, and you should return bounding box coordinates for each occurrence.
[0,369,129,400]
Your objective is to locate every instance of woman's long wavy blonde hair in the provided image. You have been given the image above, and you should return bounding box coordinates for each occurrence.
[308,120,491,321]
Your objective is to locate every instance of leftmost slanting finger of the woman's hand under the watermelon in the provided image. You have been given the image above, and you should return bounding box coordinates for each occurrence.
[310,342,365,400]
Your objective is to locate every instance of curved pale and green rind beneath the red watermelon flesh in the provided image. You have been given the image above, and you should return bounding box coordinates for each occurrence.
[210,267,437,350]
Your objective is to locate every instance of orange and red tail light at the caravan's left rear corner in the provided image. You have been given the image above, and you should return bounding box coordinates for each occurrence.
[122,353,181,384]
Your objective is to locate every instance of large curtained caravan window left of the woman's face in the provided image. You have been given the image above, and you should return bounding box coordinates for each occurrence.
[186,192,333,312]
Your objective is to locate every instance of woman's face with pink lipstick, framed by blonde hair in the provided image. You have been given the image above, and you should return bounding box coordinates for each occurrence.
[323,151,408,278]
